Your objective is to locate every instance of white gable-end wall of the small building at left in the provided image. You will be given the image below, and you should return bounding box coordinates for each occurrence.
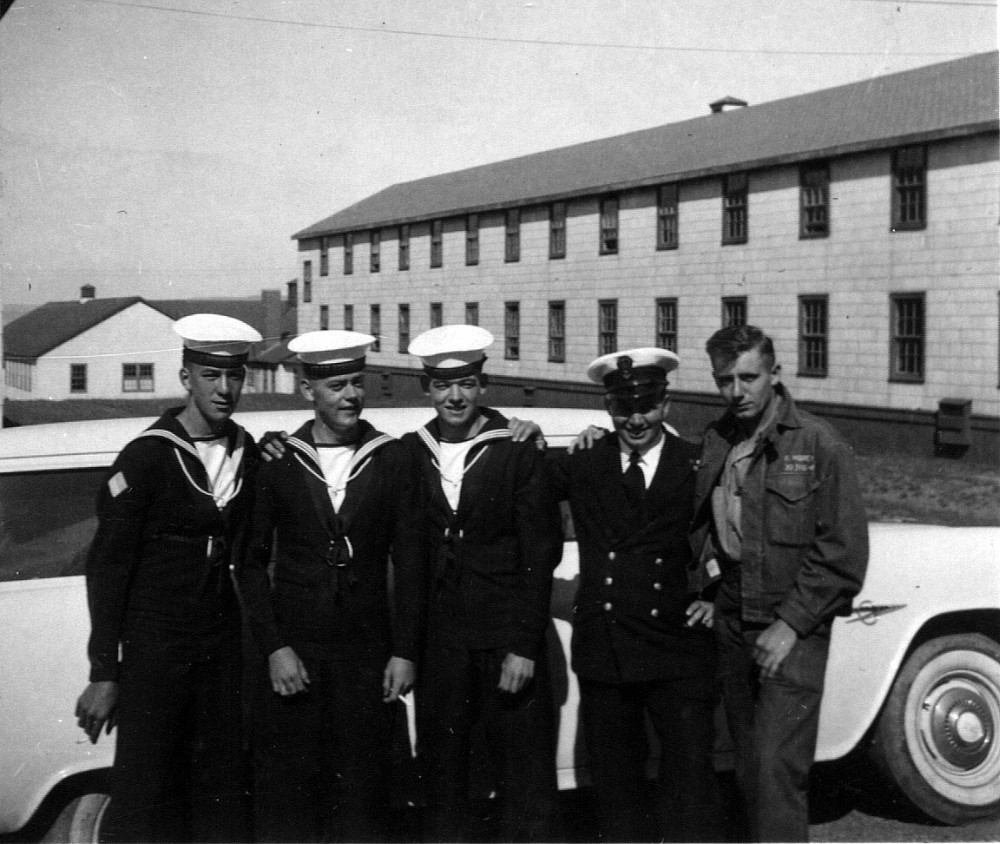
[22,303,184,399]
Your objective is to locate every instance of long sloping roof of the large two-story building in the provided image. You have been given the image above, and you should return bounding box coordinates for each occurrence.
[292,52,1000,240]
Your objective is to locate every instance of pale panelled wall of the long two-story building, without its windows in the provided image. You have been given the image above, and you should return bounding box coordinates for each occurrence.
[299,134,1000,428]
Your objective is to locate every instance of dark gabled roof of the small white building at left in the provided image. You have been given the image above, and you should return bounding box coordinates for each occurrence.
[3,296,174,360]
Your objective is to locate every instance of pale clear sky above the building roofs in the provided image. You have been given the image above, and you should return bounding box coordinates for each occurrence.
[0,0,997,305]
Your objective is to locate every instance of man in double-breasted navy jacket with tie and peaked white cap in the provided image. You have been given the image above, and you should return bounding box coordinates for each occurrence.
[547,348,725,841]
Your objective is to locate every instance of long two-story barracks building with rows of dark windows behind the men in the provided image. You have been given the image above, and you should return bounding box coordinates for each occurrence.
[293,53,1000,459]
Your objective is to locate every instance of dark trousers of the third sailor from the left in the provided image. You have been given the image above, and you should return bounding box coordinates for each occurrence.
[417,645,557,841]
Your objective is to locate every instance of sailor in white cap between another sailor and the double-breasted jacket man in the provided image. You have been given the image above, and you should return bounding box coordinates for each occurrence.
[403,325,562,841]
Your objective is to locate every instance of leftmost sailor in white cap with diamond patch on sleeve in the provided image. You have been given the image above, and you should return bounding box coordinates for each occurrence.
[76,314,261,842]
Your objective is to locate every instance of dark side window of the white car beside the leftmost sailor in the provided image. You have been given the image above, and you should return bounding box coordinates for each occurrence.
[0,468,107,582]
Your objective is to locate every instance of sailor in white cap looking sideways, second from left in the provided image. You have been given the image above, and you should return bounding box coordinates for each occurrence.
[241,331,425,841]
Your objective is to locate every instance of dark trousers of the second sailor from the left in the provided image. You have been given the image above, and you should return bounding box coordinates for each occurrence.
[255,652,394,842]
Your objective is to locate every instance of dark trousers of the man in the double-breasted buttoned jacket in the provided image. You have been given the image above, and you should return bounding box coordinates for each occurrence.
[580,674,725,841]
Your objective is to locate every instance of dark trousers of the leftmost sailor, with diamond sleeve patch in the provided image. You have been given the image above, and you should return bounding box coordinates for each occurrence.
[102,640,248,842]
